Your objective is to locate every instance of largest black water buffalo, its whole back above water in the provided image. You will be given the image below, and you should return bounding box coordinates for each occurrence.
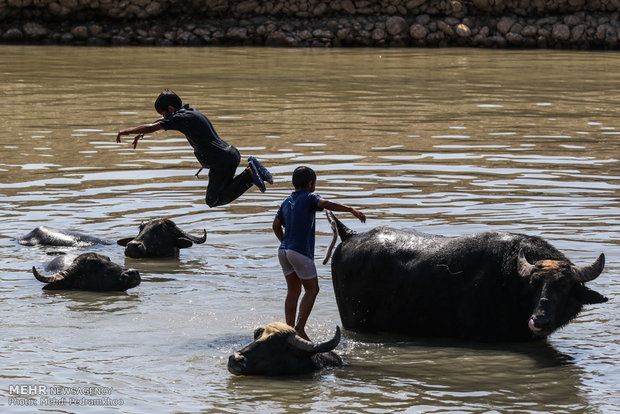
[328,213,607,342]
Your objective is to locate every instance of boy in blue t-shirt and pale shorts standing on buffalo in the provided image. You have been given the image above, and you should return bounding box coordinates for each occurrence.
[272,166,366,339]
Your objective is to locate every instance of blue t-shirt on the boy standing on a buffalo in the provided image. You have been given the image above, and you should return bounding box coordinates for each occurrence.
[276,190,323,259]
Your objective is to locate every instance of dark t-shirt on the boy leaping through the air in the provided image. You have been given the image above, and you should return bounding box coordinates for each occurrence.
[157,104,231,168]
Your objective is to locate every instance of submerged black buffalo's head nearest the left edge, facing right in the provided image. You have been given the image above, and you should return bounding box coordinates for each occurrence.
[32,253,140,292]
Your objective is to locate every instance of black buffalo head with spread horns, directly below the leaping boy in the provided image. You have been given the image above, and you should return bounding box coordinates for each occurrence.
[117,218,207,258]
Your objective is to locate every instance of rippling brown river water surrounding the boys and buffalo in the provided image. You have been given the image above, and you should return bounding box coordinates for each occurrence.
[0,46,620,413]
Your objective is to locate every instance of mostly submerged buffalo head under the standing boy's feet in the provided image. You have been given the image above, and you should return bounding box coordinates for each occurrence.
[228,322,342,375]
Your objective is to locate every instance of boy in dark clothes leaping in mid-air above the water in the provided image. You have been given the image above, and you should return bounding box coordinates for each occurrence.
[116,90,273,207]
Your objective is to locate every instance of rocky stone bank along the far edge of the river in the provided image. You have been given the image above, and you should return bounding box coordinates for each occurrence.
[0,0,620,49]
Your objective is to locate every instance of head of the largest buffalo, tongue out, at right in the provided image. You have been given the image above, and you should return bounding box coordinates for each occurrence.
[518,250,607,337]
